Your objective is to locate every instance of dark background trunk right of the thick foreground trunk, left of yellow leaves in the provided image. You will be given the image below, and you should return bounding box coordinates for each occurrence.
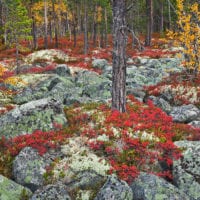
[145,0,153,46]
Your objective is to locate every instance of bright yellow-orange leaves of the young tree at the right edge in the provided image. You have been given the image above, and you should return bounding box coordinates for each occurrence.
[167,0,200,72]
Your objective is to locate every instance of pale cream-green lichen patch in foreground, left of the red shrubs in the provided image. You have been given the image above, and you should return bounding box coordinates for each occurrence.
[53,137,110,179]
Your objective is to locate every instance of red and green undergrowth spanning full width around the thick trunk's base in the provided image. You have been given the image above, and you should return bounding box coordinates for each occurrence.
[0,96,199,182]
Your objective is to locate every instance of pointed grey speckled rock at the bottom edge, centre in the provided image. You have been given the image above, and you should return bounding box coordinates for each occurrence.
[95,176,133,200]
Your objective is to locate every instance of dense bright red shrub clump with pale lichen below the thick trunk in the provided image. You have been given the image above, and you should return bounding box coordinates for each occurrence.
[78,97,181,182]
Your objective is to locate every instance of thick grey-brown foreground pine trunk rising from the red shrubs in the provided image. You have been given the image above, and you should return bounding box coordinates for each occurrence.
[112,0,127,112]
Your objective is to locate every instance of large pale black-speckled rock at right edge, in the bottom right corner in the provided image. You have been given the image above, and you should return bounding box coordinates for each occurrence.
[173,141,200,200]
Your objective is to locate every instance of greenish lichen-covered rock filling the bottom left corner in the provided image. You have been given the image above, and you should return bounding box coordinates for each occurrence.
[0,175,32,200]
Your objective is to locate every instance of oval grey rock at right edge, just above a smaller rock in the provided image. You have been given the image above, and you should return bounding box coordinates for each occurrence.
[170,104,200,123]
